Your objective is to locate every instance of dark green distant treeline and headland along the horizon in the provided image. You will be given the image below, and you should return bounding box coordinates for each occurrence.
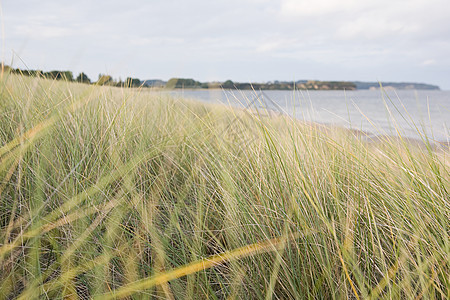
[3,65,439,90]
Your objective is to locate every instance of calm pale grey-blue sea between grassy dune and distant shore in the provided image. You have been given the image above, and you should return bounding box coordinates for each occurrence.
[157,90,450,142]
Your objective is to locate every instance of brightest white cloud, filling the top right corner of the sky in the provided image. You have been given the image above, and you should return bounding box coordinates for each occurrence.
[280,0,450,40]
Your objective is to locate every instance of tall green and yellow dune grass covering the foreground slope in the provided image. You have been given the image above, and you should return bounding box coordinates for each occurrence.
[0,74,450,299]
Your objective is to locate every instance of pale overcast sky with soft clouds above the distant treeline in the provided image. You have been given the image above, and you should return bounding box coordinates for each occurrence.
[0,0,450,90]
